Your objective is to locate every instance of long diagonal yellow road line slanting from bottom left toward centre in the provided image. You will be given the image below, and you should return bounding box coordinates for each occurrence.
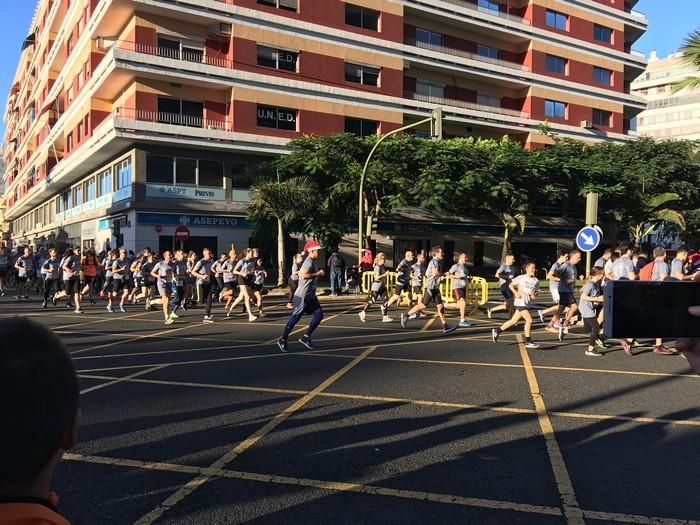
[136,346,377,525]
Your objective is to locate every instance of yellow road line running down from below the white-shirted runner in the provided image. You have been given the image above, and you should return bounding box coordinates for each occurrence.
[517,335,585,525]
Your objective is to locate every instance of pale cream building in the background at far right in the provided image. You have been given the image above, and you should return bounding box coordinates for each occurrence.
[631,52,700,140]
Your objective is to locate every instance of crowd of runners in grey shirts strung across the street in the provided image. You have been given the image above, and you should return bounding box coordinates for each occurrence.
[0,241,700,357]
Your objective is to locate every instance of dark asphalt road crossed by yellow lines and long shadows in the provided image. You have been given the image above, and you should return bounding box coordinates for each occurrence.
[0,290,700,525]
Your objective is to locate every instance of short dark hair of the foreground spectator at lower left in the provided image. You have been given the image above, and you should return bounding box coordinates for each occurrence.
[0,317,79,487]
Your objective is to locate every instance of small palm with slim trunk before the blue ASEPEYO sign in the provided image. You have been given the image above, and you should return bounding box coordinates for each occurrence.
[248,175,317,286]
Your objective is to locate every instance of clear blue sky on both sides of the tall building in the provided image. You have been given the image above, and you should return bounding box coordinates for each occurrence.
[0,0,700,140]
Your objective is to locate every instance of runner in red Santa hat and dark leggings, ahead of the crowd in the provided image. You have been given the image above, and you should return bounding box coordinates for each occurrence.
[277,241,325,352]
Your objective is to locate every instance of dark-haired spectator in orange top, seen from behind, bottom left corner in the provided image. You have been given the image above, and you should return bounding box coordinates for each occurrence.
[0,317,80,525]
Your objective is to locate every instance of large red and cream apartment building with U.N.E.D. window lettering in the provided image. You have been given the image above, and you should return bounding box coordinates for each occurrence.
[4,0,647,251]
